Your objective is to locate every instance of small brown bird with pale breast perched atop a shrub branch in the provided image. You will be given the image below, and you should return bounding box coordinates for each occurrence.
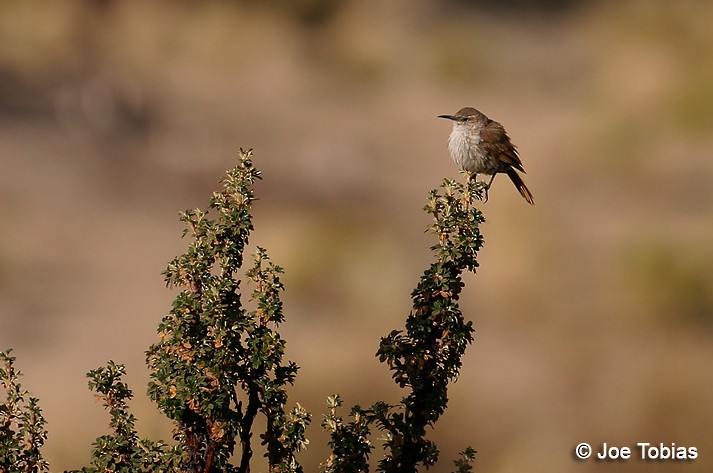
[438,107,535,205]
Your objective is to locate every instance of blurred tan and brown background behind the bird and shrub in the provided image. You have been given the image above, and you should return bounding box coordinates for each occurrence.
[0,0,713,473]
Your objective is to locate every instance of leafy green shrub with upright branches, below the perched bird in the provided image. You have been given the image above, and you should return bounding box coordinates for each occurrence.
[0,150,484,473]
